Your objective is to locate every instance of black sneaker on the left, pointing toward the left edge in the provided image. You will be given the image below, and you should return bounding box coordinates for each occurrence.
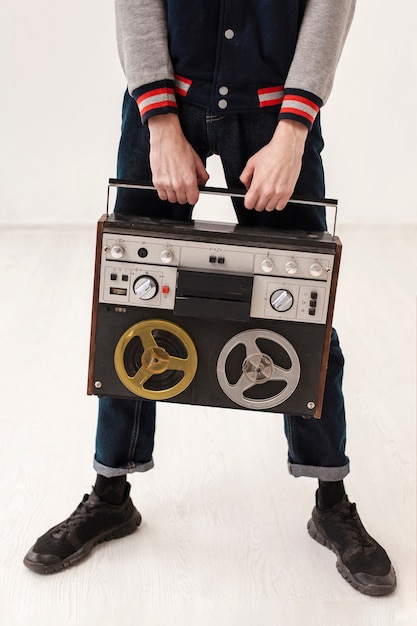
[23,483,141,574]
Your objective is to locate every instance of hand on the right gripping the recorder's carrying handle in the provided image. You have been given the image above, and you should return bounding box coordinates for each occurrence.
[240,120,308,211]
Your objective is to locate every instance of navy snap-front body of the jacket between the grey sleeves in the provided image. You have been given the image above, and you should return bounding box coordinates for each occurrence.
[166,0,306,112]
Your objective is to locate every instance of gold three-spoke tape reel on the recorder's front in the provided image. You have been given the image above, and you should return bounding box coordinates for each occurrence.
[114,319,198,400]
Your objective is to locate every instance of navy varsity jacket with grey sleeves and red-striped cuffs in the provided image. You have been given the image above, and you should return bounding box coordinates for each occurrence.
[116,0,355,128]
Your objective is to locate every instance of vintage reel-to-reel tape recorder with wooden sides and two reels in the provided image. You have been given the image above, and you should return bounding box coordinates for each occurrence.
[88,181,341,417]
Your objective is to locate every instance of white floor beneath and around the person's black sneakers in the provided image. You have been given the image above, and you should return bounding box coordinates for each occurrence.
[0,225,417,626]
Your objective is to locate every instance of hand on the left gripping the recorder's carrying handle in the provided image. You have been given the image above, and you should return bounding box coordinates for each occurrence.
[148,113,209,205]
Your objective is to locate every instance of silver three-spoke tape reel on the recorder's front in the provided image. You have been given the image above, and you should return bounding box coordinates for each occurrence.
[217,328,301,410]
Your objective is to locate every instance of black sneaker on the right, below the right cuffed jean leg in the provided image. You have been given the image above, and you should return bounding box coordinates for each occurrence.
[307,495,397,596]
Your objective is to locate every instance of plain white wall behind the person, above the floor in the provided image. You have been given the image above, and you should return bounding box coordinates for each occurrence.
[0,0,417,224]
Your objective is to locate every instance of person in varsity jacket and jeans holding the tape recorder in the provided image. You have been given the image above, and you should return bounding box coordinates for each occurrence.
[24,0,396,595]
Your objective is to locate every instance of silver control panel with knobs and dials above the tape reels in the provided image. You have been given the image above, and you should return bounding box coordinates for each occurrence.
[100,236,333,324]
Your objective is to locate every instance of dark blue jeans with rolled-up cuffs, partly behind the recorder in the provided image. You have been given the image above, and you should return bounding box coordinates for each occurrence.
[94,93,349,481]
